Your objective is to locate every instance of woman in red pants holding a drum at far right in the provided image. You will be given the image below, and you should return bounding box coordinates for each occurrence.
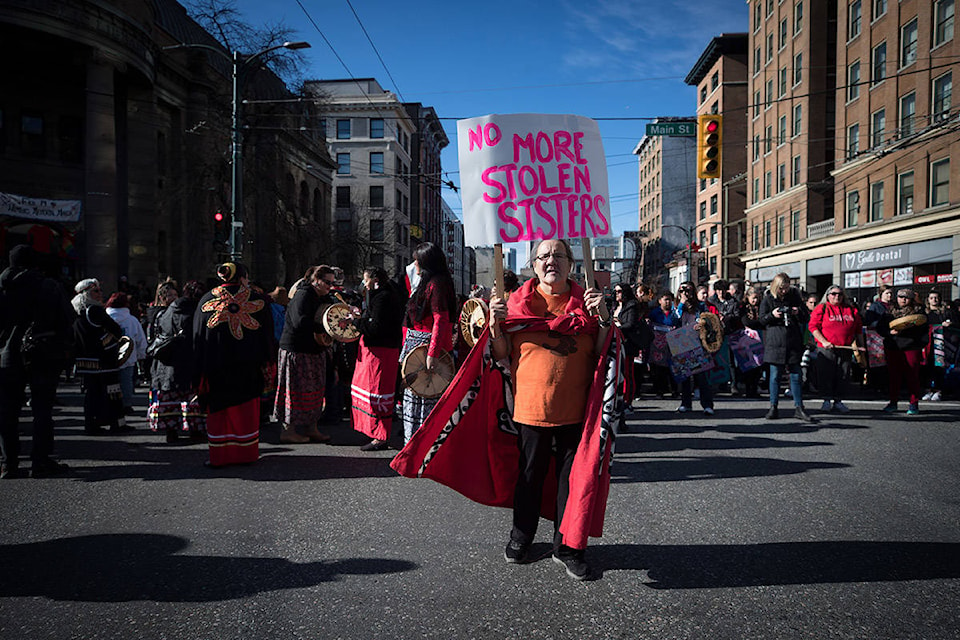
[877,289,927,416]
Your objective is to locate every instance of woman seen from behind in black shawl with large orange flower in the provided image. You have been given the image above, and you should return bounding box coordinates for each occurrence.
[193,262,274,467]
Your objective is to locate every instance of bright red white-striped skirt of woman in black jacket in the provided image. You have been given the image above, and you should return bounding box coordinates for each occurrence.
[350,337,400,440]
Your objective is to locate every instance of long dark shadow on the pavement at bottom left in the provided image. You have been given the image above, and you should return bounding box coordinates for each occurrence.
[0,534,417,602]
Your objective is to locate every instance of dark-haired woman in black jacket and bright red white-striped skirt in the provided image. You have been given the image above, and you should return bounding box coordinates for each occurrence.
[351,267,404,451]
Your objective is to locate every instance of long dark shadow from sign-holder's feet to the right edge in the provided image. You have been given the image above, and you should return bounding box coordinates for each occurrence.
[589,540,960,589]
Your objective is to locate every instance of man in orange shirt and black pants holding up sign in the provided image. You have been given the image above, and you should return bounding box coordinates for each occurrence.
[490,239,611,580]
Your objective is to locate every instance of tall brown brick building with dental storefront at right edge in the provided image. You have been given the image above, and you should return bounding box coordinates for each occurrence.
[743,0,960,300]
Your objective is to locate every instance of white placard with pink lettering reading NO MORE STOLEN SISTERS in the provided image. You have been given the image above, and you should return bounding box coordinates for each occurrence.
[457,114,612,247]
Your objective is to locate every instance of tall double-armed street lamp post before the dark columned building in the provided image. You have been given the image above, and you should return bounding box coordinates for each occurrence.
[163,41,310,261]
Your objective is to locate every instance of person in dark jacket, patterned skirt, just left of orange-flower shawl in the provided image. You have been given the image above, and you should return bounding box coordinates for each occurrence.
[147,280,206,443]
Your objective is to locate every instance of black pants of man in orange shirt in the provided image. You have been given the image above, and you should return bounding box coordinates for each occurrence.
[510,424,583,549]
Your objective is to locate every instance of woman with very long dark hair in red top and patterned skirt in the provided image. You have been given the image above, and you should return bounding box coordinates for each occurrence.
[400,242,457,443]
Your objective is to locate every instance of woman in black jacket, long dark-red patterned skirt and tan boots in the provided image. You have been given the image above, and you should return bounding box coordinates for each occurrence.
[273,265,337,444]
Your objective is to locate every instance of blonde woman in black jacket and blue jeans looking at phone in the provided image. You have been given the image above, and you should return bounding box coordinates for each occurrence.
[760,273,816,422]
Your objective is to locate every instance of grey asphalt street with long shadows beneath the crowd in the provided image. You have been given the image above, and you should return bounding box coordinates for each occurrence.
[0,387,960,640]
